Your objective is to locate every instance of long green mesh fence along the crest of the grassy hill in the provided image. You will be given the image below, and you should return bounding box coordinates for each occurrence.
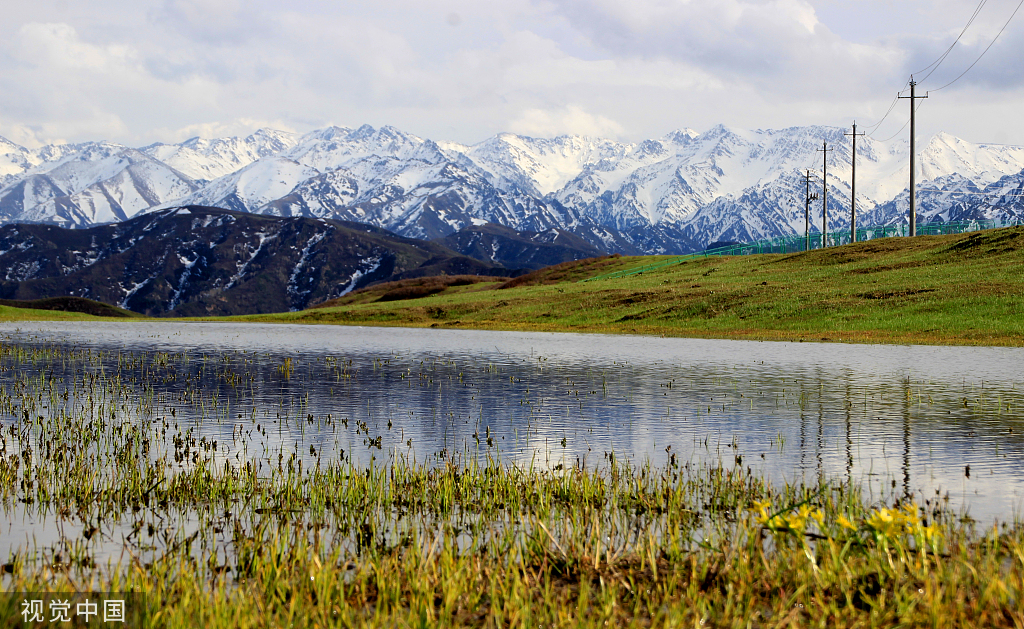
[582,217,1024,282]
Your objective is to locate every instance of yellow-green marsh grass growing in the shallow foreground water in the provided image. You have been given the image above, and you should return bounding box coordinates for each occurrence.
[0,344,1024,627]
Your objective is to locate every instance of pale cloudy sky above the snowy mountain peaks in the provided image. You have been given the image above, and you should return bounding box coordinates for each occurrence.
[0,0,1024,146]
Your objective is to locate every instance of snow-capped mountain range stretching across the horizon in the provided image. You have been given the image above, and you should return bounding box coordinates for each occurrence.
[0,125,1024,253]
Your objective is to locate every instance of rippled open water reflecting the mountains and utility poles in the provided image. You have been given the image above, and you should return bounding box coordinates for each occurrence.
[0,322,1024,521]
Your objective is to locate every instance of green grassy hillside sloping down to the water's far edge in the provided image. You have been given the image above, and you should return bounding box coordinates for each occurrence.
[242,227,1024,345]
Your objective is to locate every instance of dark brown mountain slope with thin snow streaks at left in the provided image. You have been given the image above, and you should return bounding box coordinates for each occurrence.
[0,207,508,317]
